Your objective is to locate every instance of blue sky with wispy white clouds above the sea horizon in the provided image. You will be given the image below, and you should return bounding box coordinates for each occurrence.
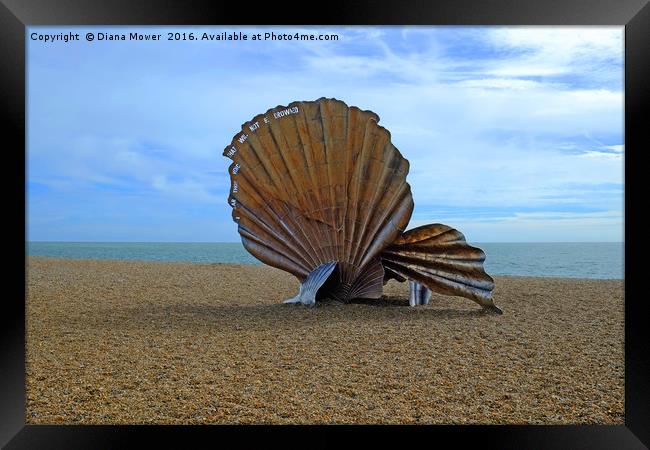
[26,26,624,242]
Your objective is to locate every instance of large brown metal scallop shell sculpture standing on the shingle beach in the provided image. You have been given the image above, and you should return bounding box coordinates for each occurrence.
[224,98,501,313]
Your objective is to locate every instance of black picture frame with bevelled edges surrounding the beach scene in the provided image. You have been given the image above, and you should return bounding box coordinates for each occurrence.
[0,0,650,449]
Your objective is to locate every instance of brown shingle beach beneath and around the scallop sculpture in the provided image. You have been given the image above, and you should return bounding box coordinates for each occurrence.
[26,257,624,424]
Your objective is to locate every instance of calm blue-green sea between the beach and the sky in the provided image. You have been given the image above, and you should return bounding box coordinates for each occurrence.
[26,242,624,279]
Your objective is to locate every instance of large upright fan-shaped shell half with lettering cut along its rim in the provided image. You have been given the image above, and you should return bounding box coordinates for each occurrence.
[224,98,413,300]
